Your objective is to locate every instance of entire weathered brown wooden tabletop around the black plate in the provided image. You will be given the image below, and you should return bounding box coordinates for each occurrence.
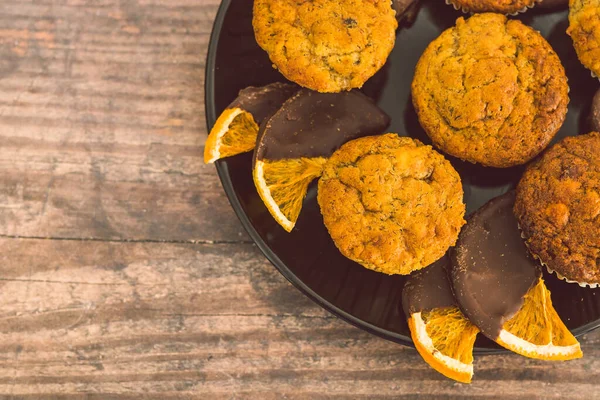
[0,0,600,400]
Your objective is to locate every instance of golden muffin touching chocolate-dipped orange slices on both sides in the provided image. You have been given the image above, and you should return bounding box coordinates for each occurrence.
[317,134,465,275]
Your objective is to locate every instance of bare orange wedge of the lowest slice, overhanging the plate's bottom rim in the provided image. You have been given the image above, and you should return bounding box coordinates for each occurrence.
[408,306,479,383]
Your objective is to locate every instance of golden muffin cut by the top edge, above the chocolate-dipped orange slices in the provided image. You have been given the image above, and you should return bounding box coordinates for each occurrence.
[252,0,398,92]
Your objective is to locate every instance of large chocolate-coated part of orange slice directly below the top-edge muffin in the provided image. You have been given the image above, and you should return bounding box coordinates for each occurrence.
[254,89,390,160]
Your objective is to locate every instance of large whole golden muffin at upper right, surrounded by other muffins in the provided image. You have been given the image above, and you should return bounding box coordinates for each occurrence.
[412,13,569,167]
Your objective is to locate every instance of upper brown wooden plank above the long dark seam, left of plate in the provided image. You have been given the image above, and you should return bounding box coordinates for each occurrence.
[0,0,247,242]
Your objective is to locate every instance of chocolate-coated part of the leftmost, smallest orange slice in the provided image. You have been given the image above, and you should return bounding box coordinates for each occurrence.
[227,82,300,125]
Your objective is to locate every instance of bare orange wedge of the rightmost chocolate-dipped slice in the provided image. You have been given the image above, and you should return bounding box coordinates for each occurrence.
[496,278,583,360]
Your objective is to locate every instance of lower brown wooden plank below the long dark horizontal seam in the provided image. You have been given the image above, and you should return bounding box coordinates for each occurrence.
[0,239,600,399]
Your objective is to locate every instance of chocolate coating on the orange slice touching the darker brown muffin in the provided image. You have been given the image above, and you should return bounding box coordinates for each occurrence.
[450,191,542,340]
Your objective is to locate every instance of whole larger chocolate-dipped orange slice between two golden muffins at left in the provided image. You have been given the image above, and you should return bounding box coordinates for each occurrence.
[253,89,390,232]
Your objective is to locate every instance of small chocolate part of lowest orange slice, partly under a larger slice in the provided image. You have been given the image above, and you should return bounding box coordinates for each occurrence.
[402,256,457,318]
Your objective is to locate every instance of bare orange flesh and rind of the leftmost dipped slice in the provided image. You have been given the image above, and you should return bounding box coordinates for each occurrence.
[204,108,258,164]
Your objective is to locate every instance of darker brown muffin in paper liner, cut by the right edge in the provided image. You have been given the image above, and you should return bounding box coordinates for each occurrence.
[515,132,600,284]
